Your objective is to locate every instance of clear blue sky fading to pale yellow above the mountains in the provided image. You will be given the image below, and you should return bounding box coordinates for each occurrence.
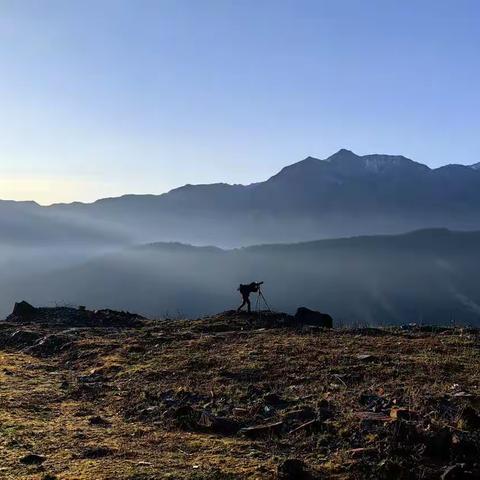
[0,0,480,204]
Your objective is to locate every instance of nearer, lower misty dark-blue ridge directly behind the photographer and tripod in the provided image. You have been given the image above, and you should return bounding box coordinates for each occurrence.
[6,229,480,326]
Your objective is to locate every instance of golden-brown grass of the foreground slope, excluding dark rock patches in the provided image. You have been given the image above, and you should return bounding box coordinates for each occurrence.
[0,317,480,480]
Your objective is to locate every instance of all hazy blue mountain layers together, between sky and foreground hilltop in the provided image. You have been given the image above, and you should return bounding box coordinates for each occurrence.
[0,149,480,325]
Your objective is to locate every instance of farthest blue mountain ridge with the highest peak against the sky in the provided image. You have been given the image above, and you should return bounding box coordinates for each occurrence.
[0,149,480,246]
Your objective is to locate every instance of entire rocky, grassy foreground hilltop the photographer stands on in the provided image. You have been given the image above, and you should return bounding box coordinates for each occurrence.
[0,312,480,480]
